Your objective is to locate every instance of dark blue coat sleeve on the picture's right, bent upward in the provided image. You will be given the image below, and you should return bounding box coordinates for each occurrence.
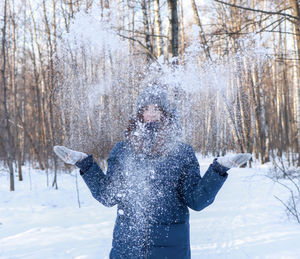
[178,146,229,211]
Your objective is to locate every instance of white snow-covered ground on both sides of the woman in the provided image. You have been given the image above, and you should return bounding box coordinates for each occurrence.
[0,158,300,259]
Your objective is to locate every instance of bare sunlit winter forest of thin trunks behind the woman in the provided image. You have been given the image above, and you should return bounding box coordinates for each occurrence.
[0,0,300,190]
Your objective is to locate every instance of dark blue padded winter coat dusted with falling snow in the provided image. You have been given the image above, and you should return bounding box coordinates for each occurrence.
[76,141,228,259]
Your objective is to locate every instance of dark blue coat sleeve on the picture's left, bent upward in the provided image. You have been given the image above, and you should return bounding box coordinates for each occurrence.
[76,143,126,207]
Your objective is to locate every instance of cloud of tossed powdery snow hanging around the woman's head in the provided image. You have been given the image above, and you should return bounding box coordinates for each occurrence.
[54,8,269,157]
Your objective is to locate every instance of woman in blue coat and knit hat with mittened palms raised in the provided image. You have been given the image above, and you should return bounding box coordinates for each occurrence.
[54,85,250,259]
